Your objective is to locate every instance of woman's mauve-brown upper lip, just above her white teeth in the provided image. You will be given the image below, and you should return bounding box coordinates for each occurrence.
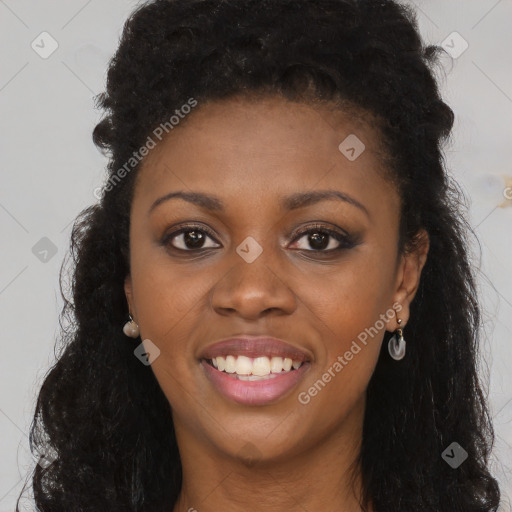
[200,335,312,362]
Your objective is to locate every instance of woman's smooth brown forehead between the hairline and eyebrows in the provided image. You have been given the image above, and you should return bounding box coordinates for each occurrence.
[136,97,394,214]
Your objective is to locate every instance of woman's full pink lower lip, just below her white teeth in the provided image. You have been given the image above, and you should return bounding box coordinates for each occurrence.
[201,359,311,405]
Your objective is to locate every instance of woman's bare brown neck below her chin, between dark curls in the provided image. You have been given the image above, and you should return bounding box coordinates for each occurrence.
[173,400,364,512]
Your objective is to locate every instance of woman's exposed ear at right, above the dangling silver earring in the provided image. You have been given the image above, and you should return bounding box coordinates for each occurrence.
[386,229,430,332]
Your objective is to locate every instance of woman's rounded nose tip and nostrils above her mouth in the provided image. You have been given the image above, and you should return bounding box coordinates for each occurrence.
[211,255,297,320]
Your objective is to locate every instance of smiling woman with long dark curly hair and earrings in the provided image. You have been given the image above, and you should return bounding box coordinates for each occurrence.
[17,0,500,512]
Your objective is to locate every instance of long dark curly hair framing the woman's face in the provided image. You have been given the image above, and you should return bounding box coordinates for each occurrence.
[17,0,500,512]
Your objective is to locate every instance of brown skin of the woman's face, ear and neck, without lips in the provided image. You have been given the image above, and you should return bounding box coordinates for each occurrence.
[125,98,429,512]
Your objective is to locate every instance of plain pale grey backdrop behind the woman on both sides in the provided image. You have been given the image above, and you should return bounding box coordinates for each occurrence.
[0,0,512,512]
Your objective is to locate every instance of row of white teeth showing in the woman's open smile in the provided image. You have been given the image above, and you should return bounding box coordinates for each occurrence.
[211,355,303,380]
